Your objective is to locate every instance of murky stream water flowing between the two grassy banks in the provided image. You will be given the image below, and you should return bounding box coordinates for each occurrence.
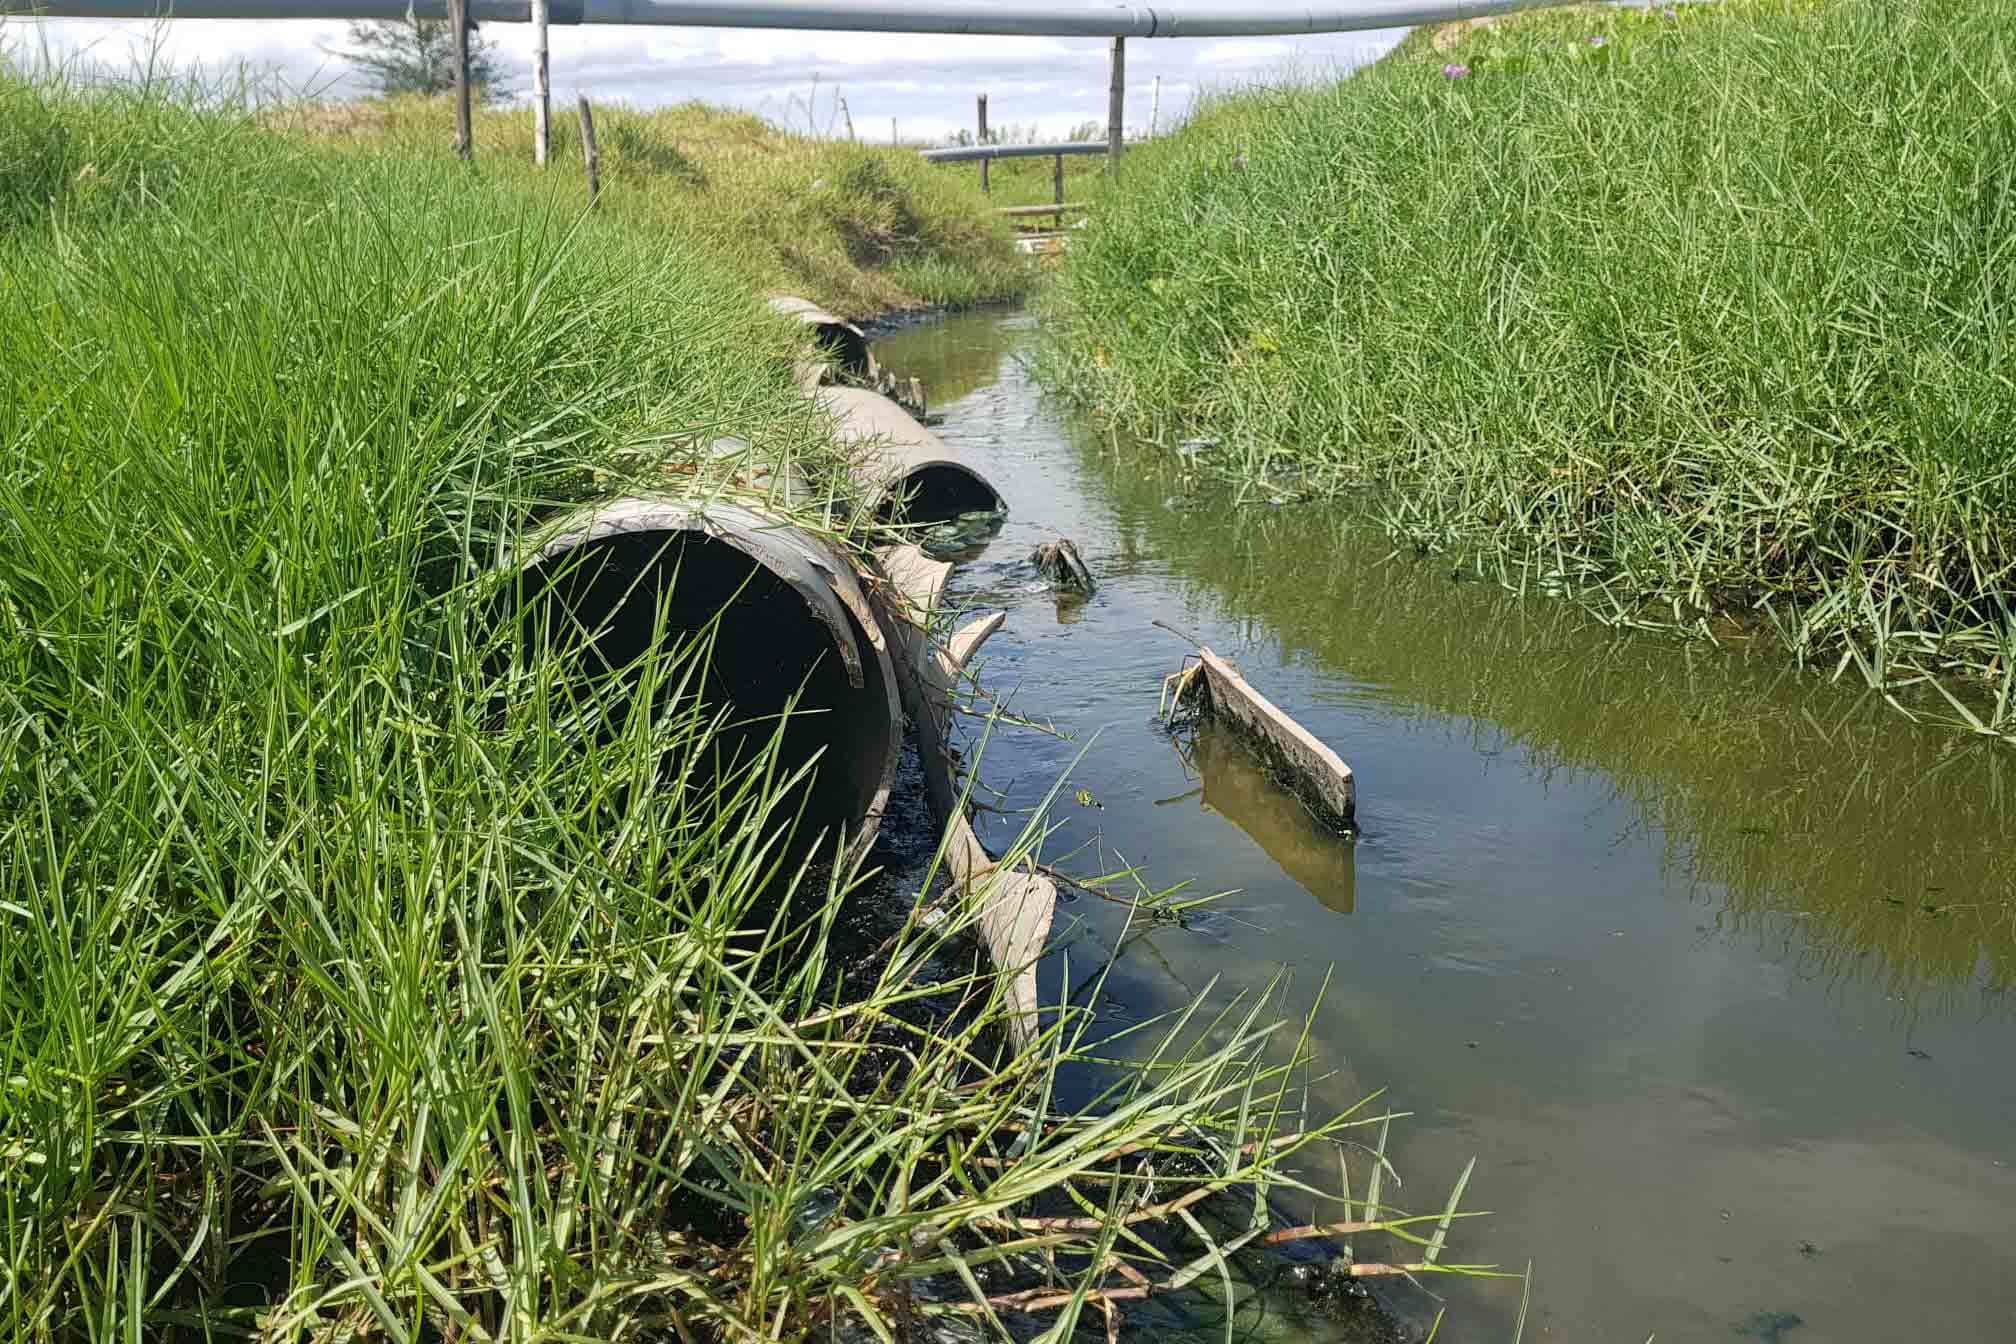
[877,314,2016,1344]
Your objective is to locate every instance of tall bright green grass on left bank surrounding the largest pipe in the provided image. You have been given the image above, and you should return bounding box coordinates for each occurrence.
[0,77,1499,1340]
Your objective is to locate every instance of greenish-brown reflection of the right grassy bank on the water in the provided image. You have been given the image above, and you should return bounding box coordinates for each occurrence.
[1085,483,2016,1014]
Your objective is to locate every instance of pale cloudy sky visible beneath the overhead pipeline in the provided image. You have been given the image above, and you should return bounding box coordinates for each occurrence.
[0,9,1401,139]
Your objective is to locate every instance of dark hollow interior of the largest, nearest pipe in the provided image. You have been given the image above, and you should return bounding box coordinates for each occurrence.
[520,530,895,852]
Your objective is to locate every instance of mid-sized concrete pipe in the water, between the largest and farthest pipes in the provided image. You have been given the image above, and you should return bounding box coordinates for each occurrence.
[812,387,1008,526]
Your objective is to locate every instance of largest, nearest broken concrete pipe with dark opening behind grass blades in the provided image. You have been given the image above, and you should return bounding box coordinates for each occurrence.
[512,496,903,860]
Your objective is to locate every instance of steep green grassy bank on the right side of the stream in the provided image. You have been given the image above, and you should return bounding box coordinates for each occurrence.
[1048,0,2016,735]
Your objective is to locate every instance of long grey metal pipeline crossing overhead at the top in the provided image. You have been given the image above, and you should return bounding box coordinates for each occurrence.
[0,0,1562,38]
